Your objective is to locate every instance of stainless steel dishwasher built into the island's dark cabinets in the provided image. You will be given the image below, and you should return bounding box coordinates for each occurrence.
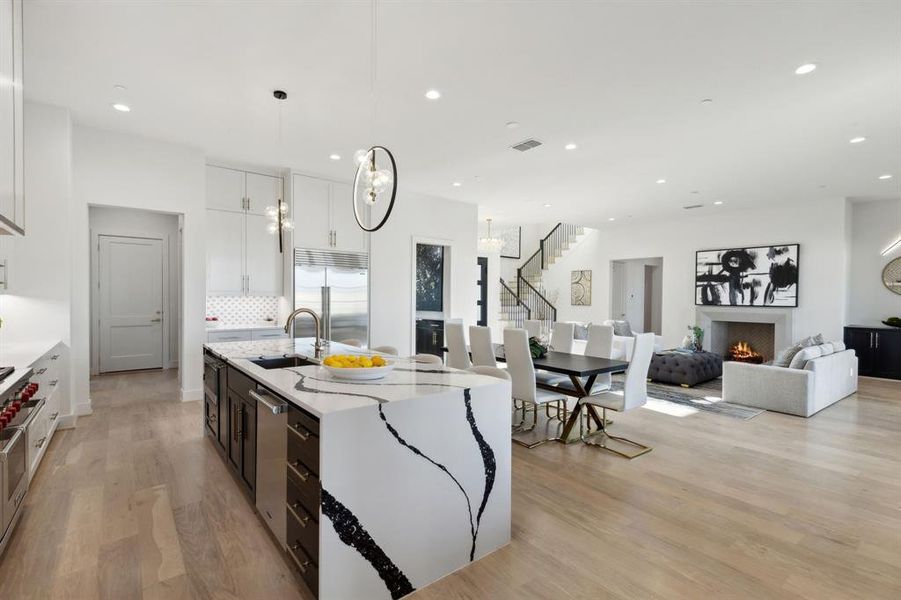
[249,386,288,548]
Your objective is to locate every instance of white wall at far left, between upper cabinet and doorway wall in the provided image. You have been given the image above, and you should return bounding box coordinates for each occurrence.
[0,102,76,424]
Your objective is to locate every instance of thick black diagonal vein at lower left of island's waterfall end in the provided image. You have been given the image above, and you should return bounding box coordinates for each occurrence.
[321,490,416,598]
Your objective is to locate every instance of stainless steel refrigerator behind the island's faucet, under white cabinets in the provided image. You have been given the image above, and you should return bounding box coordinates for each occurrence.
[294,248,369,346]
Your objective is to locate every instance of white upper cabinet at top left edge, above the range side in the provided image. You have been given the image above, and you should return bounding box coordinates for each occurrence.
[0,0,25,235]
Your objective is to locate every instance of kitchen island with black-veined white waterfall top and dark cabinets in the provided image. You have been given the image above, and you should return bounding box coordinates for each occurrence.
[204,338,511,599]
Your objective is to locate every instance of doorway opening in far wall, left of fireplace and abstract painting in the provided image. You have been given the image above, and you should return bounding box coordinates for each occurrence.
[610,257,663,335]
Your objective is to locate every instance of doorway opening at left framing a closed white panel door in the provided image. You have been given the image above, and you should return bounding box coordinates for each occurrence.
[88,206,181,375]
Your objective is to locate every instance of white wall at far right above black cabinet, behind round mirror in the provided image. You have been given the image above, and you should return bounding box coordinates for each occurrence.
[847,199,901,325]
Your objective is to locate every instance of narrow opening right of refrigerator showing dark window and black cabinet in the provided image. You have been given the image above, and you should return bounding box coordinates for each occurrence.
[412,239,452,356]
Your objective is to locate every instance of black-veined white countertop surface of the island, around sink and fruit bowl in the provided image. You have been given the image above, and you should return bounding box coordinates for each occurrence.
[204,338,498,417]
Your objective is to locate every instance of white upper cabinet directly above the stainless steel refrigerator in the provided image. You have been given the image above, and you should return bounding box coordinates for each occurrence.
[292,175,367,252]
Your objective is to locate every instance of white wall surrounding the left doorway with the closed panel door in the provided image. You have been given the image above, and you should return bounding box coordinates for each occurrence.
[71,125,206,400]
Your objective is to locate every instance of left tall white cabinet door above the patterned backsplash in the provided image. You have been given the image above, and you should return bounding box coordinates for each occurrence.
[206,210,244,296]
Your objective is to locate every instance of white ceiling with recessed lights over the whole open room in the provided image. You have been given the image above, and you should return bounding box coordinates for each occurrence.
[25,0,901,224]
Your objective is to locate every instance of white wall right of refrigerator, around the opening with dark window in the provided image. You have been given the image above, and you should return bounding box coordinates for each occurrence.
[369,191,478,355]
